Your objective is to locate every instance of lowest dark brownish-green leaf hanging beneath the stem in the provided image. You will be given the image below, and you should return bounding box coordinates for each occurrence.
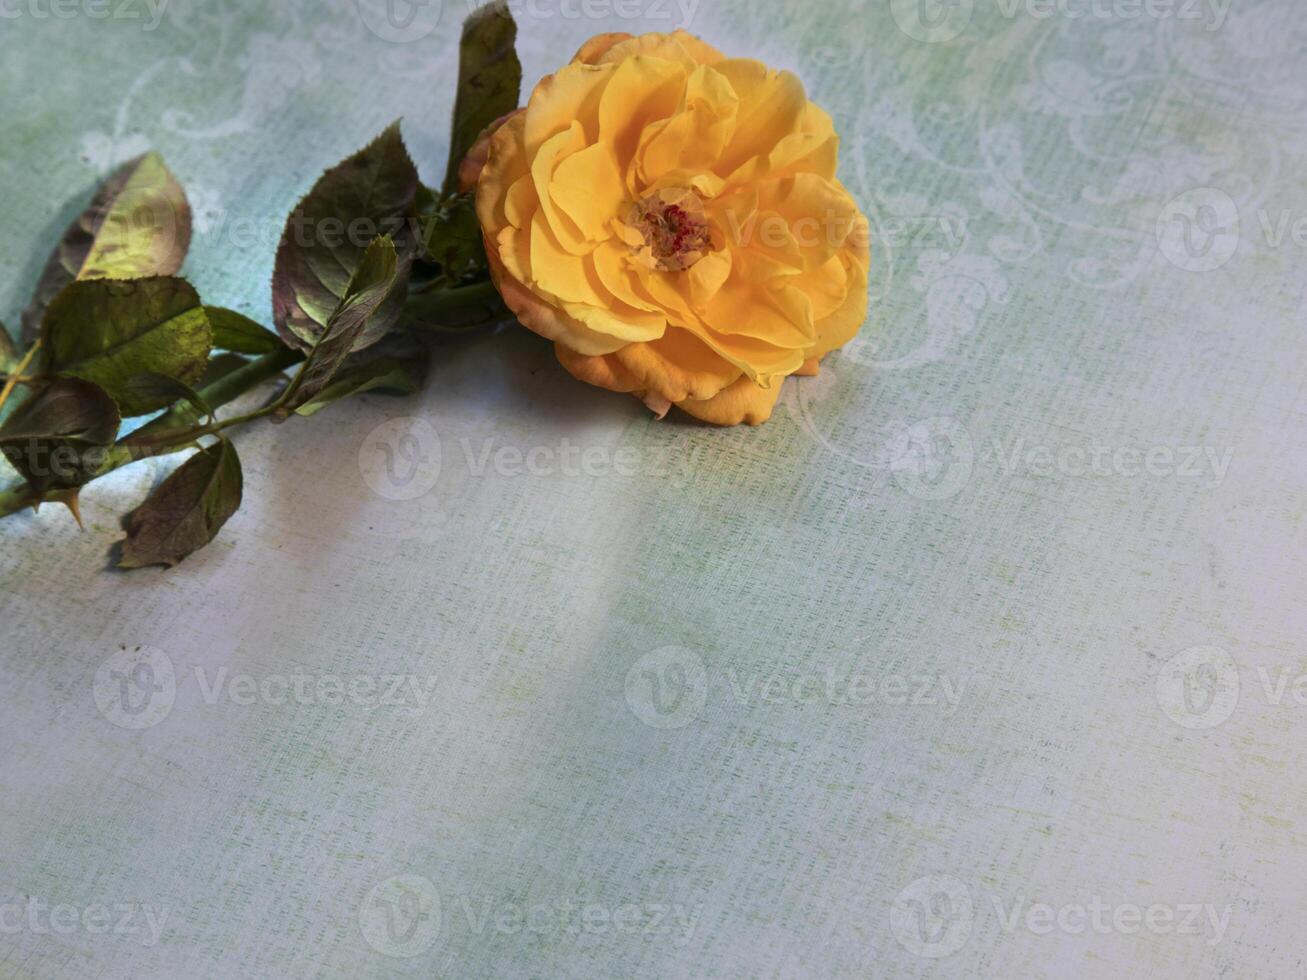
[118,439,244,568]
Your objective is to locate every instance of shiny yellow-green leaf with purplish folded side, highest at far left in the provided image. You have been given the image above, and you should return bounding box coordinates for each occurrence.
[22,153,191,344]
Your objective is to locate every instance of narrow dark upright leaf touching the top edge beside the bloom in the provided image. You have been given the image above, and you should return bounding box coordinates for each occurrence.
[444,3,521,195]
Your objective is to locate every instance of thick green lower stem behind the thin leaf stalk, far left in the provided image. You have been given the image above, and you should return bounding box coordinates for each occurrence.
[0,349,305,517]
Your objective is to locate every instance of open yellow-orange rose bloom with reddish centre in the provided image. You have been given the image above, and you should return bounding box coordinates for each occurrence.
[460,30,869,425]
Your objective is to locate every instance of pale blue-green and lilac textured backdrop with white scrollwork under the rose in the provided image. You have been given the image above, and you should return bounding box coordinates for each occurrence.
[0,0,1307,979]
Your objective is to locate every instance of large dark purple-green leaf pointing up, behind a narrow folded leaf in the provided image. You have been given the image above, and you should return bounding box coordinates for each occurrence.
[272,123,418,351]
